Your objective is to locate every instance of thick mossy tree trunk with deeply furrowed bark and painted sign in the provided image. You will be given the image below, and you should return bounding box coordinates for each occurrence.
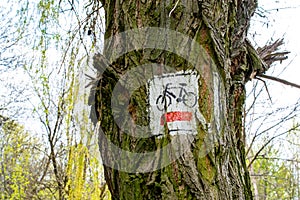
[93,0,262,200]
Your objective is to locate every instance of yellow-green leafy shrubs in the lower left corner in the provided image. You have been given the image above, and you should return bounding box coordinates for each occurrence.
[0,117,51,199]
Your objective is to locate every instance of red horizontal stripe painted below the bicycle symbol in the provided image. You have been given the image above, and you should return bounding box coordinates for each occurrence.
[160,111,193,125]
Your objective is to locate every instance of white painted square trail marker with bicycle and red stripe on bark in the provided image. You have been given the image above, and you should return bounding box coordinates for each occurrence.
[148,70,206,136]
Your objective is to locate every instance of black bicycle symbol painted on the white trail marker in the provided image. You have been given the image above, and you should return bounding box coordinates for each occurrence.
[156,83,197,111]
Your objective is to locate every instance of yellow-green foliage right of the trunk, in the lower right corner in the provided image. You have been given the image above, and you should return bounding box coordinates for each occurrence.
[251,147,298,200]
